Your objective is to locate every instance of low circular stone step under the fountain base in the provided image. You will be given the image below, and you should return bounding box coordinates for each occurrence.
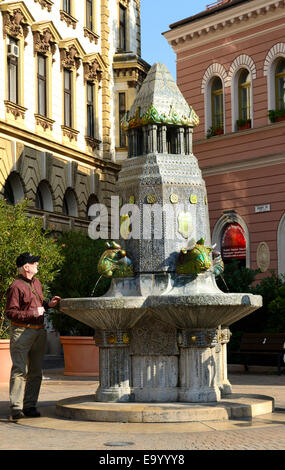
[56,393,274,423]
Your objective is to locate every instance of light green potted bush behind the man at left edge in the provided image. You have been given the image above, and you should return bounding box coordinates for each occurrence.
[0,199,63,382]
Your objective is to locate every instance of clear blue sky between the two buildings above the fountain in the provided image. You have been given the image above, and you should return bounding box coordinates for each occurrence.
[141,0,209,80]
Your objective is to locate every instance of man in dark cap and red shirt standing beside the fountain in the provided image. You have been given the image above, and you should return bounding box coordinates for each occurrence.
[6,253,60,421]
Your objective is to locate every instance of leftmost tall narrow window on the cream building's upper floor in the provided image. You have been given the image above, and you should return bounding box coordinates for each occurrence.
[7,38,19,104]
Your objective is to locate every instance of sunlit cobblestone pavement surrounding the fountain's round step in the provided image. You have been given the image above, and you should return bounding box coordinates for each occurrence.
[0,369,285,452]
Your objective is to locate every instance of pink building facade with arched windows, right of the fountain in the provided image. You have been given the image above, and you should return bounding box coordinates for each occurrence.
[164,0,285,278]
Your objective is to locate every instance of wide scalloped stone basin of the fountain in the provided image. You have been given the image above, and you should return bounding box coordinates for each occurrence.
[60,292,262,330]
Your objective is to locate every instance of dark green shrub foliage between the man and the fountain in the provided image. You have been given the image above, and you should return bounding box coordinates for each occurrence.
[48,231,110,336]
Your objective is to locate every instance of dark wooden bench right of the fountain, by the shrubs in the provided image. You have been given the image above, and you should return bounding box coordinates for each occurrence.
[231,333,285,375]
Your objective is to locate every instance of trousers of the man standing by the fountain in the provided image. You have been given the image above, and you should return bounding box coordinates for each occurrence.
[10,325,46,412]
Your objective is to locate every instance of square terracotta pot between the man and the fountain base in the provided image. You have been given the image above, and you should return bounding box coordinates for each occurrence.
[60,336,99,377]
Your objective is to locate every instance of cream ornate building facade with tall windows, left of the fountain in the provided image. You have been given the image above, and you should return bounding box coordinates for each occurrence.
[0,0,149,231]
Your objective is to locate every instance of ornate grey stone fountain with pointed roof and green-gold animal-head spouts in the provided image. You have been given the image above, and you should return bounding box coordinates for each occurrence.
[61,64,262,403]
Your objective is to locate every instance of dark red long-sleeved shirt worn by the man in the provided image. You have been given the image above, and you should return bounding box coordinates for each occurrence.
[6,276,47,325]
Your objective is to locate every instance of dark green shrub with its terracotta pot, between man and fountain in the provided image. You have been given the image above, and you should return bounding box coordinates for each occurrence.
[48,231,110,376]
